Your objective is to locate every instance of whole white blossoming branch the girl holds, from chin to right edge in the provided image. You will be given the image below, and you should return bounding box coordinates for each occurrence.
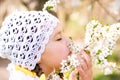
[46,20,120,80]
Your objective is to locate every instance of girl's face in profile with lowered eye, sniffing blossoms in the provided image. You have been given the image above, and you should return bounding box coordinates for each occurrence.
[41,24,71,74]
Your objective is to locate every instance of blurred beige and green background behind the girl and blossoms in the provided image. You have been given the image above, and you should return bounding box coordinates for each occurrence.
[0,0,120,80]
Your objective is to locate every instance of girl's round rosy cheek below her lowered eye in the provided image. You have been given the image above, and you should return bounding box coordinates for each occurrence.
[43,44,69,68]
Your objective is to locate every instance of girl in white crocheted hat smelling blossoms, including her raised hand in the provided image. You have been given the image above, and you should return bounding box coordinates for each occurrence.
[0,11,92,80]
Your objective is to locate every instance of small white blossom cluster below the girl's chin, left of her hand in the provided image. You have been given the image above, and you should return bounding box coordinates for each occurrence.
[47,54,80,80]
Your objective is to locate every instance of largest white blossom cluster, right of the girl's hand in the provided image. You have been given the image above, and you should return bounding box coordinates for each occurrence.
[84,20,120,74]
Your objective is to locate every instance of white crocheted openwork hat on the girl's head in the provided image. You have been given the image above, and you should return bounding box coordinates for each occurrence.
[0,11,59,70]
